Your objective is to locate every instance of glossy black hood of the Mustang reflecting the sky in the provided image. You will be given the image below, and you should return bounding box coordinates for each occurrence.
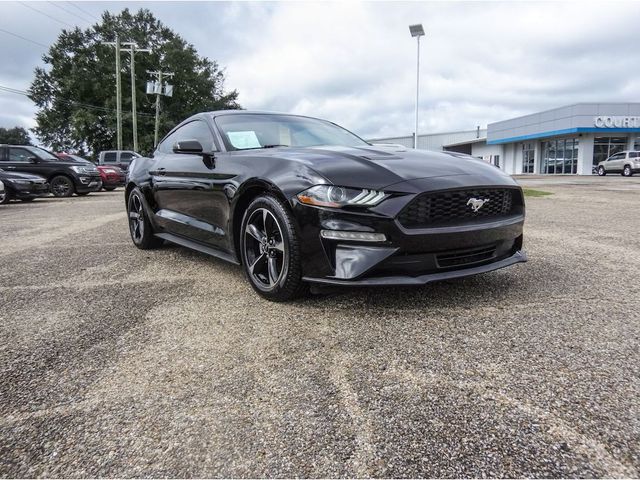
[251,146,515,189]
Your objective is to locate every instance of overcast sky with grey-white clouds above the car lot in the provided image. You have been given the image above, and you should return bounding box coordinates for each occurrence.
[0,1,640,142]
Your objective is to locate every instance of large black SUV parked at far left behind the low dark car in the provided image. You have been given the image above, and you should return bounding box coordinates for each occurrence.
[0,145,102,197]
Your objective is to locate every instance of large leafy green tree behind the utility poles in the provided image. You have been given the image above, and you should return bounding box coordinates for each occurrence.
[29,9,240,154]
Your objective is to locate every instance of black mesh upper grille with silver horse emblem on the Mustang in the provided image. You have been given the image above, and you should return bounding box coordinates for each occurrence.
[398,188,522,228]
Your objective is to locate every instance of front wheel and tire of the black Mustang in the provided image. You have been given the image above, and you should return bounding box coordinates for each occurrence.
[240,195,306,302]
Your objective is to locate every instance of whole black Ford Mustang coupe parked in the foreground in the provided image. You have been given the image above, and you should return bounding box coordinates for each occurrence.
[125,111,526,301]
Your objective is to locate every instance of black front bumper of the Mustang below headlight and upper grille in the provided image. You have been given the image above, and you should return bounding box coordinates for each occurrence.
[291,179,527,286]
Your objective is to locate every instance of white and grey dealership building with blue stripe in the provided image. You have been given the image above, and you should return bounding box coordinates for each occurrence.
[371,103,640,175]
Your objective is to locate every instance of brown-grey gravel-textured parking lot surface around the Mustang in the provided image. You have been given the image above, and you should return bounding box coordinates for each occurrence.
[0,176,640,477]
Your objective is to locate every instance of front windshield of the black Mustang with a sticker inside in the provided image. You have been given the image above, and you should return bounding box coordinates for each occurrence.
[215,113,368,150]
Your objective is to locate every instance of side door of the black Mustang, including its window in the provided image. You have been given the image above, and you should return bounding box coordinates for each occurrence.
[149,120,233,251]
